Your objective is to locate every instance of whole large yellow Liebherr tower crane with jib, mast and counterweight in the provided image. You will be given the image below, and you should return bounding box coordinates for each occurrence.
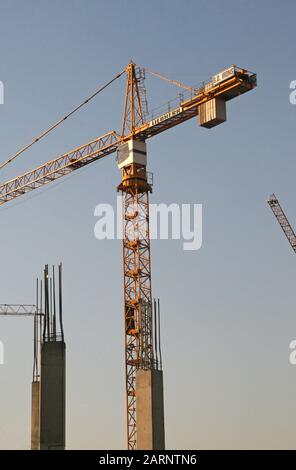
[0,62,257,449]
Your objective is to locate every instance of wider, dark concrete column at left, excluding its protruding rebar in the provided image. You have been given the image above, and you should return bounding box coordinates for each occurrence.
[40,341,66,450]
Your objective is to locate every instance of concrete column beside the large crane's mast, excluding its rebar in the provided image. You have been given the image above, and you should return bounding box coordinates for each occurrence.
[136,369,165,450]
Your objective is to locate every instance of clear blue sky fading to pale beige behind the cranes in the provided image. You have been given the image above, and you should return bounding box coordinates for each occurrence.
[0,0,296,449]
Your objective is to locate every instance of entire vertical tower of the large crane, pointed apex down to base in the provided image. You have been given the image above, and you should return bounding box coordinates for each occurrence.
[117,63,153,449]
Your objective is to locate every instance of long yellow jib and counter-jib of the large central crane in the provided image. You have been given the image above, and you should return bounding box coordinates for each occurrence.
[0,66,256,205]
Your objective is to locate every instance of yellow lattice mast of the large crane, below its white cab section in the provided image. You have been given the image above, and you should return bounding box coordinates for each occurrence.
[118,163,153,449]
